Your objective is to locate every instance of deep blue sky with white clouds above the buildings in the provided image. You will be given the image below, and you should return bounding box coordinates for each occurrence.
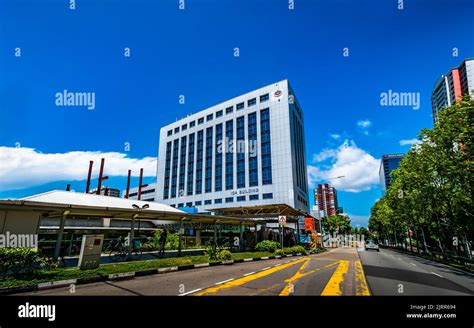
[0,0,474,224]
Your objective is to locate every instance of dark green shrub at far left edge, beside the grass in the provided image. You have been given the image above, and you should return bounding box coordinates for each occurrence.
[0,247,45,276]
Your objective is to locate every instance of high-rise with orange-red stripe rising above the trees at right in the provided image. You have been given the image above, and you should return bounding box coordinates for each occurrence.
[431,58,474,122]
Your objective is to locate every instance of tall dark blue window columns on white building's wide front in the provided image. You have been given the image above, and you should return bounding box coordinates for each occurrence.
[163,108,272,199]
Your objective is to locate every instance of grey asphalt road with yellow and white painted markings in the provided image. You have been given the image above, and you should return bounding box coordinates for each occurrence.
[16,248,474,296]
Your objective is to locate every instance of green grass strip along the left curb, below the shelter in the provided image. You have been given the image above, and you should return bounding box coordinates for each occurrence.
[0,252,273,288]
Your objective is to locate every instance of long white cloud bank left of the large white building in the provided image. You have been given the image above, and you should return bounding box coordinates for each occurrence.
[0,147,156,190]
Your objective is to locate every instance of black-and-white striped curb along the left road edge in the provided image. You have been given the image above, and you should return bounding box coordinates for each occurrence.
[0,252,322,295]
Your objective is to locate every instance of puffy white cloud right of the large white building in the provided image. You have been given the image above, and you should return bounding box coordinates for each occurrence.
[308,140,380,192]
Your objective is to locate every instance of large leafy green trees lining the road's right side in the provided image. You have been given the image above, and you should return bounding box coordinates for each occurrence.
[369,97,474,256]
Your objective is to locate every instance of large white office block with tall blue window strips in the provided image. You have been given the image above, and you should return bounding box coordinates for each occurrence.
[156,80,309,211]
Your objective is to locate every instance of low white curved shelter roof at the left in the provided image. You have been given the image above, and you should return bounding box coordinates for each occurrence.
[0,190,256,238]
